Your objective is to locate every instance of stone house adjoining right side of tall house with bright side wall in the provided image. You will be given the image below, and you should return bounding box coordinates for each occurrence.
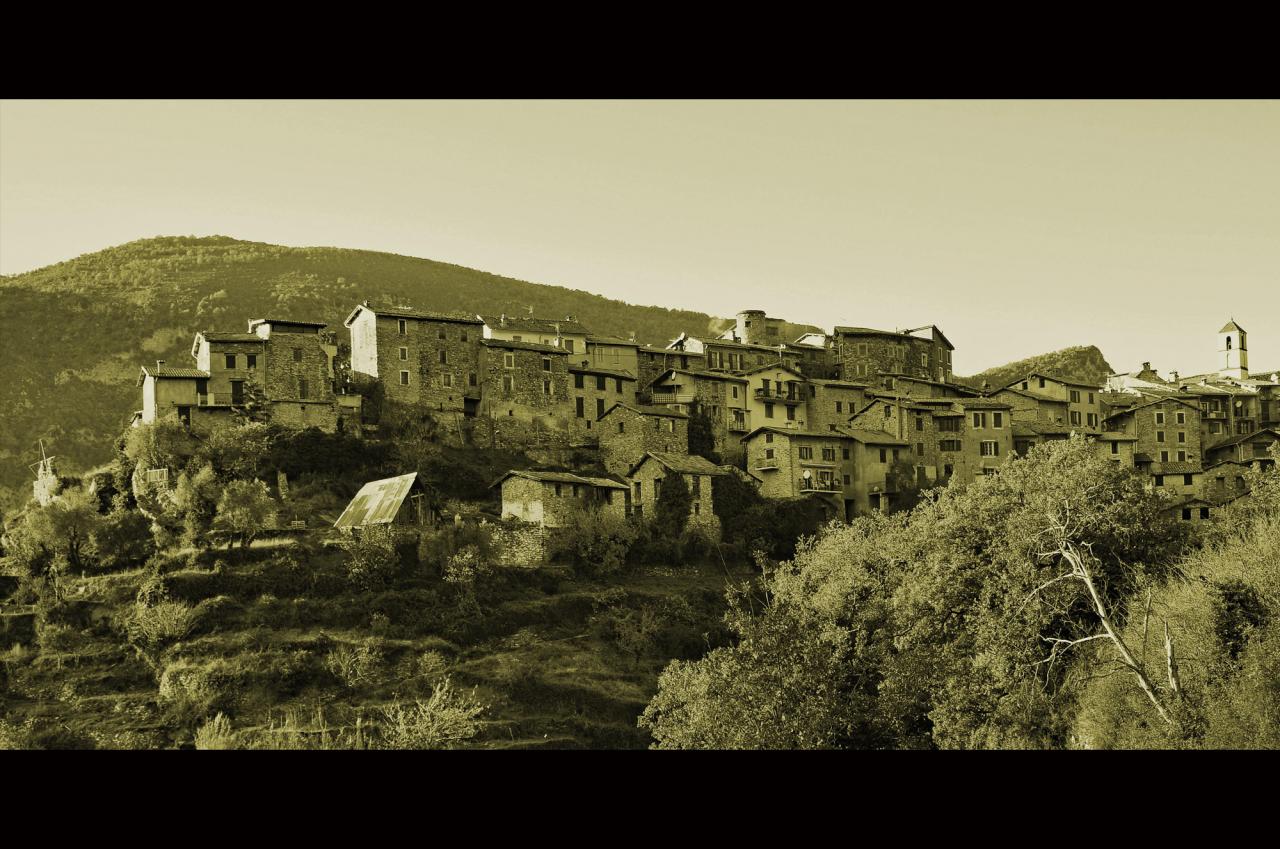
[480,338,573,430]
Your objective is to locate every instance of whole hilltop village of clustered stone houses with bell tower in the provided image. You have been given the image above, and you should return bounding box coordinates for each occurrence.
[122,307,1280,538]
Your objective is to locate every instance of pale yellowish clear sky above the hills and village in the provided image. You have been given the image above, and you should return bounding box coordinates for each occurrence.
[0,100,1280,374]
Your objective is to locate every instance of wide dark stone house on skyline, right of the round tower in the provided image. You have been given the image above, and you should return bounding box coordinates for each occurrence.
[832,325,955,383]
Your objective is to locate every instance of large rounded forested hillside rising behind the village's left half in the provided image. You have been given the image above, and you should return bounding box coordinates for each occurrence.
[0,236,736,507]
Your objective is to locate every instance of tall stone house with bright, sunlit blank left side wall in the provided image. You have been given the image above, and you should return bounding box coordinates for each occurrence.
[343,301,484,416]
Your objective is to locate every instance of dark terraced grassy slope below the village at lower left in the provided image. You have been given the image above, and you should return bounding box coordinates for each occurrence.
[0,551,742,748]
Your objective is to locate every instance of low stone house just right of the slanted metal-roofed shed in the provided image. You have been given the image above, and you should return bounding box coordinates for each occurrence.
[493,470,627,528]
